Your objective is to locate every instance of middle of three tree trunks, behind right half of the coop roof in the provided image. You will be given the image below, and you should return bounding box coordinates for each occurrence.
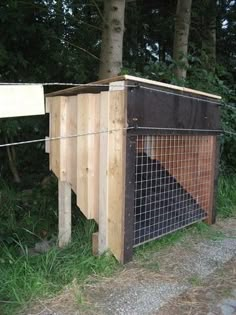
[173,0,192,80]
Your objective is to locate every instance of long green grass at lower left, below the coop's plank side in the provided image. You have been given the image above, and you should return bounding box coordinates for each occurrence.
[0,223,119,315]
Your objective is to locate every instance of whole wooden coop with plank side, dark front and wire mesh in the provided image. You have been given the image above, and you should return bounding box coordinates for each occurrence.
[46,76,220,262]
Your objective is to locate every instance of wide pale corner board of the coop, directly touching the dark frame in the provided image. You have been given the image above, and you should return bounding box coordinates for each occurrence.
[107,91,126,261]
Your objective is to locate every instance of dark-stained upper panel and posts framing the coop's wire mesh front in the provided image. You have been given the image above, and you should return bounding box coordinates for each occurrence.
[123,81,220,263]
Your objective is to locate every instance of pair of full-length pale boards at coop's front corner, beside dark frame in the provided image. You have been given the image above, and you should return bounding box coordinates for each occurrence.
[99,90,126,262]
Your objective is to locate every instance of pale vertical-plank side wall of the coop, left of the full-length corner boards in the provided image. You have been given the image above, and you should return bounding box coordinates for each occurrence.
[47,94,100,222]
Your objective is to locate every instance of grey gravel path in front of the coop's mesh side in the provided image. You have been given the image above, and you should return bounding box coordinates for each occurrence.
[86,238,236,315]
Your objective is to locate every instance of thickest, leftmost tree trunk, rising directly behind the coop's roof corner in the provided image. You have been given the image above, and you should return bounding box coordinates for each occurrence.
[99,0,125,79]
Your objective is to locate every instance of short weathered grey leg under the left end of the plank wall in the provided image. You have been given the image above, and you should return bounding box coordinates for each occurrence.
[58,180,71,247]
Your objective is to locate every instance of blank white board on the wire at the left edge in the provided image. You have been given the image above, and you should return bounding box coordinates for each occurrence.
[0,84,45,118]
